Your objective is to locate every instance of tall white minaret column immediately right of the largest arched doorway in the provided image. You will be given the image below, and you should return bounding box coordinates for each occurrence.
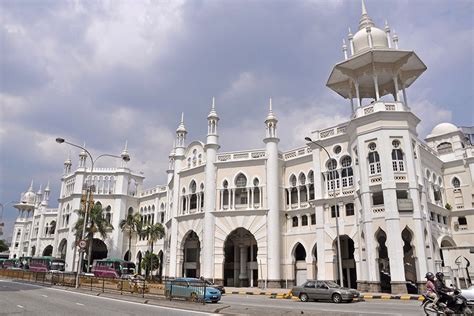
[263,98,281,288]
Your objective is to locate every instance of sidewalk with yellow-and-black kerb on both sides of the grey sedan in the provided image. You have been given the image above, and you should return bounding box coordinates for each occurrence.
[225,287,423,301]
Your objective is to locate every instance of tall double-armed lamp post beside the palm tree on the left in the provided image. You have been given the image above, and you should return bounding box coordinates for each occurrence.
[56,137,130,288]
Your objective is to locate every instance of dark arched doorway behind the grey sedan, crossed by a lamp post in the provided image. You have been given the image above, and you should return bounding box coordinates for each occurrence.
[333,235,357,289]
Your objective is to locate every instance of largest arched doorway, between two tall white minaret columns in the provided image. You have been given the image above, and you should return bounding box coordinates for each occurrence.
[224,227,258,287]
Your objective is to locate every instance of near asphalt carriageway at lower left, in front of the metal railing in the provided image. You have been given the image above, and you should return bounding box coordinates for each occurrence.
[0,280,213,316]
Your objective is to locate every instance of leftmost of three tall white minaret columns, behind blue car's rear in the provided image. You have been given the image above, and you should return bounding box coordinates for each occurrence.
[168,113,188,277]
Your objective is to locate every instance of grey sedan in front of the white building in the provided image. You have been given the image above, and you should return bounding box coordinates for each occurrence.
[291,280,360,303]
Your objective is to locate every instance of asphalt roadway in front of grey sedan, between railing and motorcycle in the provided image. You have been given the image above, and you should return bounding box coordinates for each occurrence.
[221,295,424,316]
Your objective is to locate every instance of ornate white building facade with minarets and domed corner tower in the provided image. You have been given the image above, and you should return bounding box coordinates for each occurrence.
[11,1,474,293]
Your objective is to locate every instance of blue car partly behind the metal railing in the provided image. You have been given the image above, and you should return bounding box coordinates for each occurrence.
[165,278,221,303]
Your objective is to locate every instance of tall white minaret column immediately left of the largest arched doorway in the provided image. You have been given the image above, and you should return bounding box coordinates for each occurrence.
[201,98,220,279]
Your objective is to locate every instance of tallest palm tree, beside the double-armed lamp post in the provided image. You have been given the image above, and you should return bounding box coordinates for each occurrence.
[74,203,114,272]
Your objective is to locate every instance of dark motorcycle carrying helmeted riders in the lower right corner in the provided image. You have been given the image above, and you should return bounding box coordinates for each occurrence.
[421,285,472,316]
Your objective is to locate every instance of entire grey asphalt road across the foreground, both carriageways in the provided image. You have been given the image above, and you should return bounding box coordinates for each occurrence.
[0,279,423,316]
